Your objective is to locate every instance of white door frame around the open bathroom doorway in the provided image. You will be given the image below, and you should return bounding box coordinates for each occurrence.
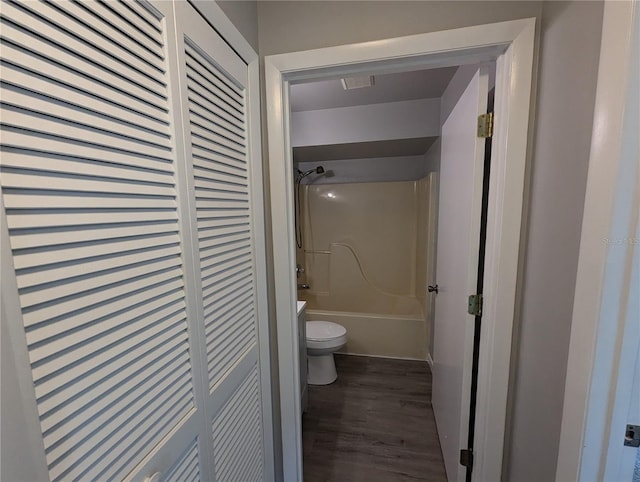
[265,18,536,480]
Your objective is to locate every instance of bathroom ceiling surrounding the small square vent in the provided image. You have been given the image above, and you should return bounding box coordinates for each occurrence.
[290,67,457,112]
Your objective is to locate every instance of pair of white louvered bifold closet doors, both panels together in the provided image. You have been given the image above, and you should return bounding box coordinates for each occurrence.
[0,1,269,482]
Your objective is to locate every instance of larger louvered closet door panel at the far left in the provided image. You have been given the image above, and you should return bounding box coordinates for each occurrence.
[0,1,212,481]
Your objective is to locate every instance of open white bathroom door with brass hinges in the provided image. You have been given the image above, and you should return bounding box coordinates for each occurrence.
[433,69,488,481]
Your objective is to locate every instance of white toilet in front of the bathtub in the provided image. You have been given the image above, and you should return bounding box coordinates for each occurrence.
[306,321,347,385]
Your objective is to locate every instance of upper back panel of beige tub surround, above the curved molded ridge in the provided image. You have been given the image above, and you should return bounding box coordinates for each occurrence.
[302,181,417,296]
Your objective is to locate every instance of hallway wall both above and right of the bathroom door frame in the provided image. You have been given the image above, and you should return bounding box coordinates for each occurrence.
[258,1,602,482]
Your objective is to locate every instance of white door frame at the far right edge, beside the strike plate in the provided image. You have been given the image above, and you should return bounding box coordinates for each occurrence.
[556,0,640,482]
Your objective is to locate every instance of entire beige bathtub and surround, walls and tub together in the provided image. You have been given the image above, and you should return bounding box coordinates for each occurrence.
[298,178,429,360]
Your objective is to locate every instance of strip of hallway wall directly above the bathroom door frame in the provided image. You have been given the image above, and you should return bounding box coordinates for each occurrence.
[258,0,541,56]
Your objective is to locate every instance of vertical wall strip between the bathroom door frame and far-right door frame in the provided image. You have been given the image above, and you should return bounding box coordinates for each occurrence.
[507,1,603,482]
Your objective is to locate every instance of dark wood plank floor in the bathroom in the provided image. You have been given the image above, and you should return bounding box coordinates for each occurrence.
[302,355,446,482]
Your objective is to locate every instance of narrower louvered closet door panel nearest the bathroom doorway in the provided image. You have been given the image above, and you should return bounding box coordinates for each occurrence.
[170,2,265,482]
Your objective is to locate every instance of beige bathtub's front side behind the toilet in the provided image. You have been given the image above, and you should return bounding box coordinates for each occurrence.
[307,310,427,360]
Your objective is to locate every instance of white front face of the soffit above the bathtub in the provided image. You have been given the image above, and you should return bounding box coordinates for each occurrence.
[291,99,440,147]
